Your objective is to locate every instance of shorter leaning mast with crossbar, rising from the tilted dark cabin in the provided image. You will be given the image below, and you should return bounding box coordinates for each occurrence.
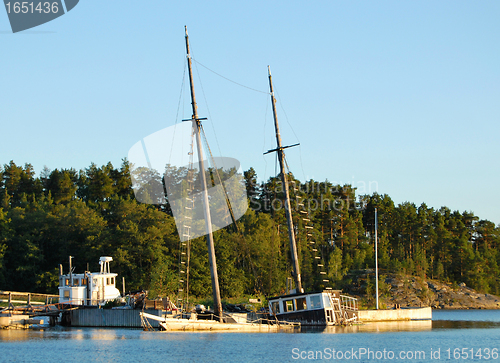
[266,66,302,292]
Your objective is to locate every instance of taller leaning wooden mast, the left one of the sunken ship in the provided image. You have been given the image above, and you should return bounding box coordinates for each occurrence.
[185,27,224,321]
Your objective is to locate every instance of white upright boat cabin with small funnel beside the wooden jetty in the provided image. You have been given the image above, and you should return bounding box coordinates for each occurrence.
[59,256,121,305]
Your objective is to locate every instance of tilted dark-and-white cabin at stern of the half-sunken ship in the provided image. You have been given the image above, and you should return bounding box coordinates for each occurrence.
[269,290,358,325]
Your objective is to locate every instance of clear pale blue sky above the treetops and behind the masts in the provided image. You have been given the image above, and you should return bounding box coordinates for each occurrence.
[0,0,500,224]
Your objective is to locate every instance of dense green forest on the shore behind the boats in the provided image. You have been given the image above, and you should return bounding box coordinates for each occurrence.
[0,160,500,299]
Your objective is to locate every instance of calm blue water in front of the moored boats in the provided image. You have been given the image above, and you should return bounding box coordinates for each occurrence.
[0,310,500,363]
